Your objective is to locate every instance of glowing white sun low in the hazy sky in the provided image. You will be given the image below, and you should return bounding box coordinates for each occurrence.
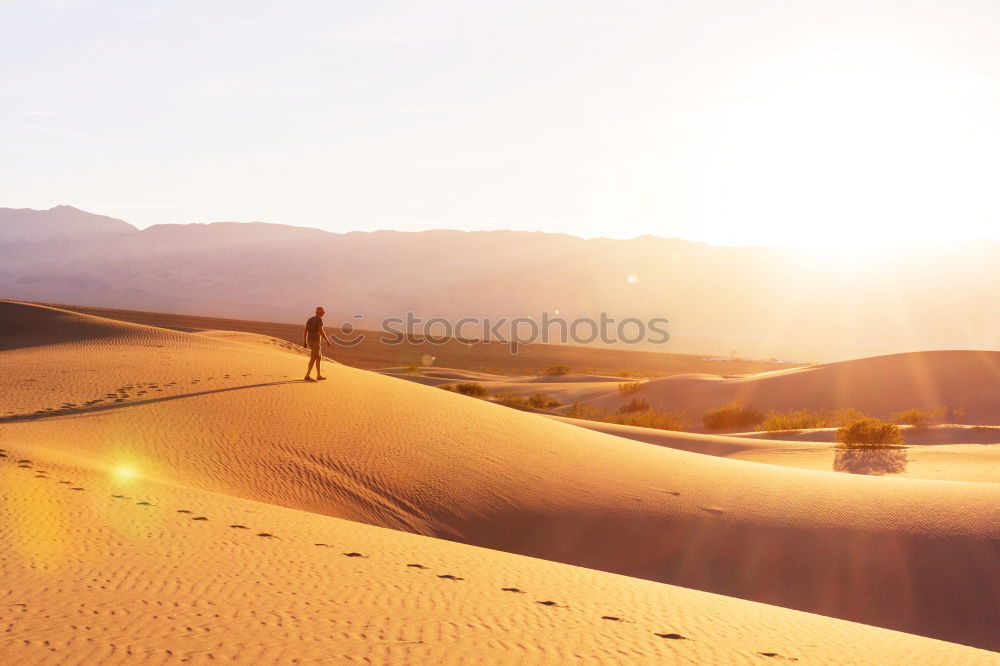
[688,68,992,253]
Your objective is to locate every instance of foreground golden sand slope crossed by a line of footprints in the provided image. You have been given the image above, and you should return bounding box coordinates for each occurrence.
[0,444,1000,666]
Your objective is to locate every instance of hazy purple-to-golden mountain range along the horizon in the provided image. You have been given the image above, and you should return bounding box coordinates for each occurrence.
[0,206,1000,361]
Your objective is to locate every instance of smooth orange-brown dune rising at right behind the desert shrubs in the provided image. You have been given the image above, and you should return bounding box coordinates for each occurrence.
[591,351,1000,427]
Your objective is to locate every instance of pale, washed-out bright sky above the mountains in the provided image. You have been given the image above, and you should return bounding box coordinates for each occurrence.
[0,0,1000,246]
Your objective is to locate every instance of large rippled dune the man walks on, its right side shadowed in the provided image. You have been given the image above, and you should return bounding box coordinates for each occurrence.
[0,303,1000,650]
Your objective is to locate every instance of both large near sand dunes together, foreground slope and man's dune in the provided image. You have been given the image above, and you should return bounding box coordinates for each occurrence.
[0,302,1000,664]
